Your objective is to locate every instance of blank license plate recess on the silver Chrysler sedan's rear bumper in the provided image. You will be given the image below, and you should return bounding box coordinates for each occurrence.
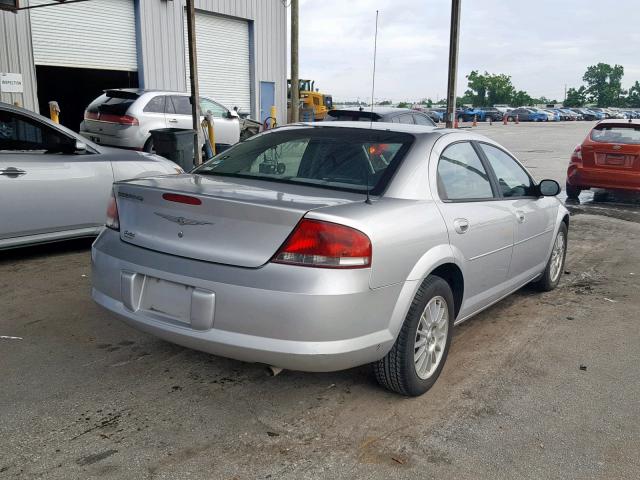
[120,271,215,330]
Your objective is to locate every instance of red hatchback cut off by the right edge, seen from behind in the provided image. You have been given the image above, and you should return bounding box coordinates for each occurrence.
[567,119,640,198]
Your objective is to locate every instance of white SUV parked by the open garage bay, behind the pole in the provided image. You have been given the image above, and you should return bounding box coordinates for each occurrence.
[80,88,240,152]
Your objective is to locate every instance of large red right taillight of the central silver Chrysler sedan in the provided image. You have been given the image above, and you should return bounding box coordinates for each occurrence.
[272,219,371,268]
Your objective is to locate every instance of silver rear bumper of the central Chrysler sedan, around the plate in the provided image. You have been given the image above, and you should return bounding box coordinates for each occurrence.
[92,229,403,371]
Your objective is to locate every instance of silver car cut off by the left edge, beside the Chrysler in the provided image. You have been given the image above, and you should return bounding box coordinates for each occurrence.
[0,103,182,249]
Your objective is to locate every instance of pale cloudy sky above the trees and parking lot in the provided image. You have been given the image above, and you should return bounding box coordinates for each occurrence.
[292,0,640,101]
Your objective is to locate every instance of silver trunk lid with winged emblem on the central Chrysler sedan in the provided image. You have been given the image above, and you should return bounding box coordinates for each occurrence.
[116,174,362,268]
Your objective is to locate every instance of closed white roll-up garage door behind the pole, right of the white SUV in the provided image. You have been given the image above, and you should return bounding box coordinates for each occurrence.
[184,13,251,112]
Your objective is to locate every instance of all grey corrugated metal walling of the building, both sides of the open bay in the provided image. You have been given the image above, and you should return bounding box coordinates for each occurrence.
[0,0,287,123]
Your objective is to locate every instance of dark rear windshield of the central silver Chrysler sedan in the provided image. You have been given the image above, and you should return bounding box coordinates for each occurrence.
[193,127,414,195]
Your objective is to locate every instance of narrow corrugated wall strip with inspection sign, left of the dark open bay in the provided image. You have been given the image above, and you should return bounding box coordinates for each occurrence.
[0,7,38,111]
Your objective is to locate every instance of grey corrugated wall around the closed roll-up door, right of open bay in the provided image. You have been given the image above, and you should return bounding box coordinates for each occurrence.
[138,0,287,123]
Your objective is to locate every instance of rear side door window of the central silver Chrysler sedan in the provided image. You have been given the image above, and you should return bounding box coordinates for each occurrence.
[437,142,493,201]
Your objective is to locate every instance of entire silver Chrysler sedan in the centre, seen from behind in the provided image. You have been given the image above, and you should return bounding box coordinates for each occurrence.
[92,122,569,395]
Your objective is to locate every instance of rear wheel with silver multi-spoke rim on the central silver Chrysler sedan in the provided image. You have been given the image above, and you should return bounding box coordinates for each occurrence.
[373,275,455,397]
